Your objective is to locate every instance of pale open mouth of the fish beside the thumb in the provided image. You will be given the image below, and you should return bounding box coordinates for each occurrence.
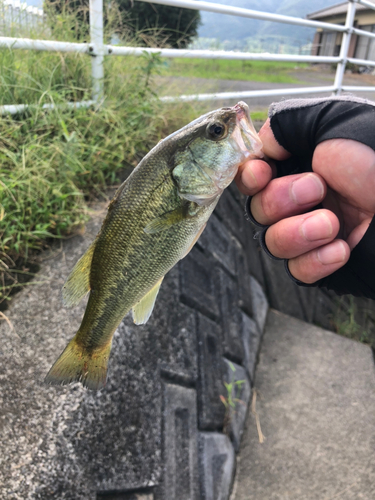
[232,101,264,159]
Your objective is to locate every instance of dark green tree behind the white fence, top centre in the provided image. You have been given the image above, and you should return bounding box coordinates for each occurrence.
[116,0,201,48]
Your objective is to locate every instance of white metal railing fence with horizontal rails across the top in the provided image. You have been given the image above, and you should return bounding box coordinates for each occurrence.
[0,0,375,114]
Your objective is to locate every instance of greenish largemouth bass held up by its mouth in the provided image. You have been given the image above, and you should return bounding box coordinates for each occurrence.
[45,102,263,390]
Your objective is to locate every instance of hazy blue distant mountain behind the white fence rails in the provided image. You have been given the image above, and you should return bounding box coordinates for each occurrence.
[198,0,340,45]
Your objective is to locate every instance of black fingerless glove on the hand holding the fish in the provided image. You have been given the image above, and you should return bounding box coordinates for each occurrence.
[256,96,375,299]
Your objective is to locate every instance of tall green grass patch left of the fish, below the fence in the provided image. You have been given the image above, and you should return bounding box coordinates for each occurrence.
[0,54,161,256]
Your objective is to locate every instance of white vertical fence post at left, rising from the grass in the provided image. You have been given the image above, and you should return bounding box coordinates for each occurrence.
[90,0,104,101]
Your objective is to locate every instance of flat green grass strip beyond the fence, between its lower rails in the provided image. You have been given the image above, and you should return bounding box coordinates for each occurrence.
[162,58,306,83]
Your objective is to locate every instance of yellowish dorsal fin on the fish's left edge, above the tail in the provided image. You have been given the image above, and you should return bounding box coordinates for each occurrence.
[62,240,96,307]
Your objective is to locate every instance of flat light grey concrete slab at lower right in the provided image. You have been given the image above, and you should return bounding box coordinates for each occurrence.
[232,311,375,500]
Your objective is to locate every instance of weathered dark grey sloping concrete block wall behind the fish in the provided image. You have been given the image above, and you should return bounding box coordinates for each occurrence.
[0,181,374,500]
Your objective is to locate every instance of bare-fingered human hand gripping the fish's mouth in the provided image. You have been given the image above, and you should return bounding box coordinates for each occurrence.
[236,100,375,296]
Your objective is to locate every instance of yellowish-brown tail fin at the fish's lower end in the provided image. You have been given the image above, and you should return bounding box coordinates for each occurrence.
[45,337,112,391]
